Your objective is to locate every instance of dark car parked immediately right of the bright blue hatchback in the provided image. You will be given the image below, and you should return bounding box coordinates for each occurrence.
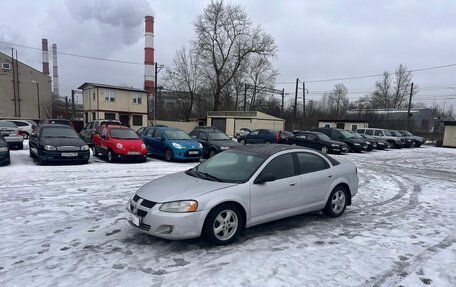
[190,127,241,157]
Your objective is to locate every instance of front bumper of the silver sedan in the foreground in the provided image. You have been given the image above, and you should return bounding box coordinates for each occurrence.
[126,205,207,240]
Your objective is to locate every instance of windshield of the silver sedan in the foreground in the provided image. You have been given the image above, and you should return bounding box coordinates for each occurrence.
[186,150,267,183]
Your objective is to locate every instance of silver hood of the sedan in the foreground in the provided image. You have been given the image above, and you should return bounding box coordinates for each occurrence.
[136,172,236,202]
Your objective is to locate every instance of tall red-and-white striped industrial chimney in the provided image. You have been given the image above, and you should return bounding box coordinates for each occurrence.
[144,16,155,118]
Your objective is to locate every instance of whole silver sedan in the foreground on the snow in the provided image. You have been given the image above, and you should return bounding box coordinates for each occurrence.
[127,144,358,245]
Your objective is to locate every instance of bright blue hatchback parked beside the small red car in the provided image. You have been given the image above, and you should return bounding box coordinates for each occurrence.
[140,127,203,161]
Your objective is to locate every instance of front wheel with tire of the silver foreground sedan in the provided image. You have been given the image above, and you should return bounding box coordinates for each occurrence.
[203,203,244,245]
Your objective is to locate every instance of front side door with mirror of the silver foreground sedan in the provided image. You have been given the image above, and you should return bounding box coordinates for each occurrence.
[250,153,302,224]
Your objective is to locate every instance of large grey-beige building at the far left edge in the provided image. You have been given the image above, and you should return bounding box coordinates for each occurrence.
[0,52,53,120]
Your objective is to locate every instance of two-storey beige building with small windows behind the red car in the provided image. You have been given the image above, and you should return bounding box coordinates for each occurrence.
[78,83,147,129]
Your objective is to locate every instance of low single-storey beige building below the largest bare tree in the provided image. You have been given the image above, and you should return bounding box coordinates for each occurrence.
[207,111,285,136]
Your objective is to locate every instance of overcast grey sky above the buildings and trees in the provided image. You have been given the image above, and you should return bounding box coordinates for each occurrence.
[0,0,456,108]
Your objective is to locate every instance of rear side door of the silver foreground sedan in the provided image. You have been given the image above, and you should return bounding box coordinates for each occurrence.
[296,152,334,211]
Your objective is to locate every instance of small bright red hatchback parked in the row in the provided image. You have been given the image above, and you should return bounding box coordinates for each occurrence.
[92,124,147,162]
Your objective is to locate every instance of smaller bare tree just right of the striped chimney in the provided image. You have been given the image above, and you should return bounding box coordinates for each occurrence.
[165,47,202,121]
